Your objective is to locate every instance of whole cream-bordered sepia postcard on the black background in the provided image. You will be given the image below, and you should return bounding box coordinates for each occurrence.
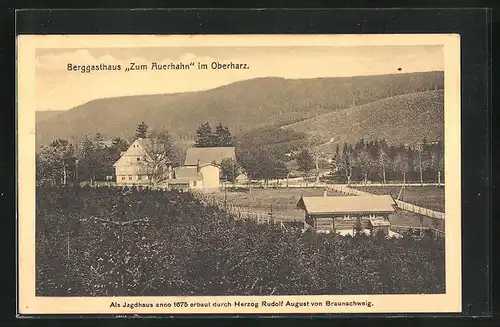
[16,34,462,315]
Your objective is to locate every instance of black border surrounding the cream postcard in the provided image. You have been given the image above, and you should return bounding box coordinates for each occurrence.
[0,8,492,322]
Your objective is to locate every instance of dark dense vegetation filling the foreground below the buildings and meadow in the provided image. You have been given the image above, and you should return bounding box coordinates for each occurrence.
[36,187,445,296]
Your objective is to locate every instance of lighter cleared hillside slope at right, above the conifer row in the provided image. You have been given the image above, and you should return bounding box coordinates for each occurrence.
[283,90,444,151]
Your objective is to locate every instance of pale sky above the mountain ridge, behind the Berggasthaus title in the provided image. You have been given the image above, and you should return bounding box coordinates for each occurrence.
[35,45,444,110]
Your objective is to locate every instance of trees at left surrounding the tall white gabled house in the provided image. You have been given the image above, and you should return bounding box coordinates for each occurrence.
[36,122,179,185]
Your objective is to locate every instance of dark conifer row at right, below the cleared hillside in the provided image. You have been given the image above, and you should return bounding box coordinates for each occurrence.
[331,139,444,184]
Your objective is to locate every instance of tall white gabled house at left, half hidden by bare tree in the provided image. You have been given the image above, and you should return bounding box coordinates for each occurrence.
[113,139,171,185]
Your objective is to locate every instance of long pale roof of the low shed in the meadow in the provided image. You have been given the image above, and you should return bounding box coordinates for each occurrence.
[297,195,396,214]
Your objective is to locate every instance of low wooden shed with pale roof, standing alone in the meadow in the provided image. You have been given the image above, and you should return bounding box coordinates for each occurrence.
[297,195,396,233]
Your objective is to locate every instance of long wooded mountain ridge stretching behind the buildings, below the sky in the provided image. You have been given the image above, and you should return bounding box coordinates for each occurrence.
[36,72,444,147]
